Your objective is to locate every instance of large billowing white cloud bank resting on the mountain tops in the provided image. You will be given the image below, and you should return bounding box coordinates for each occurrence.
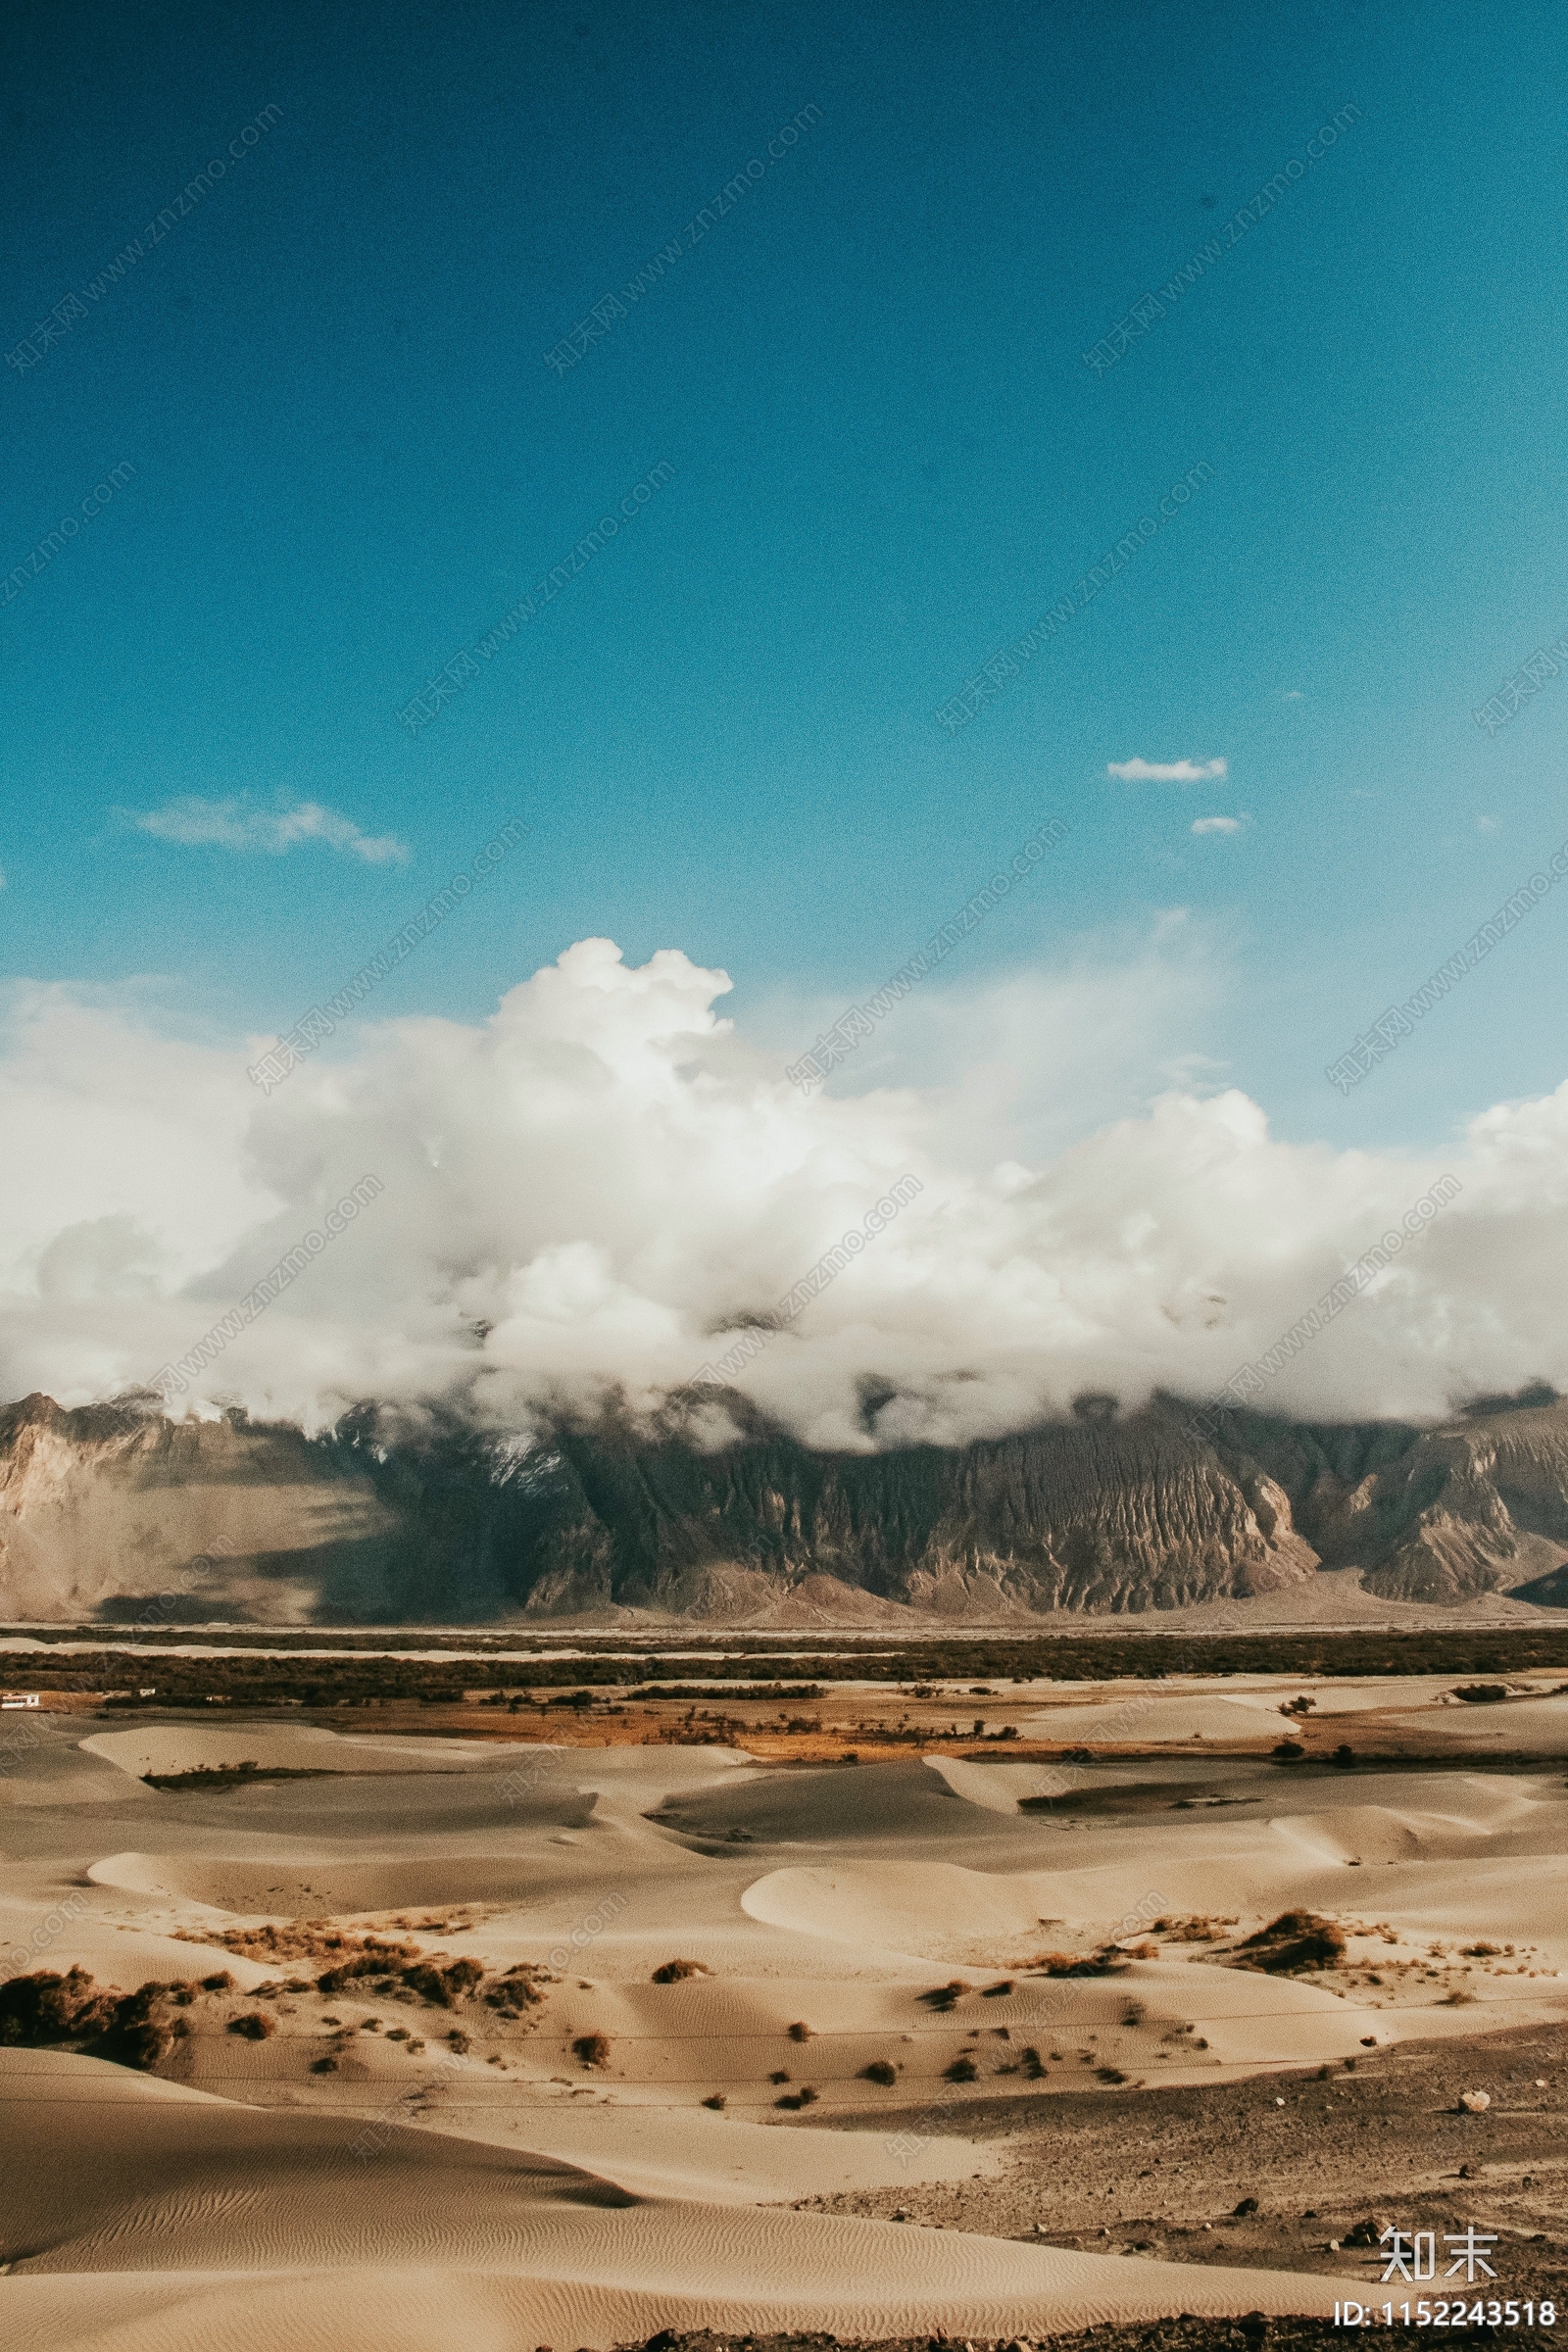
[0,941,1568,1446]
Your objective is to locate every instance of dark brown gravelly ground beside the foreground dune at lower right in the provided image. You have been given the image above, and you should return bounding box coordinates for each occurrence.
[789,2025,1568,2324]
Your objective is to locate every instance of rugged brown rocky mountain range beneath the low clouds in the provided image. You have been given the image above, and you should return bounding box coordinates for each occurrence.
[0,1397,1568,1625]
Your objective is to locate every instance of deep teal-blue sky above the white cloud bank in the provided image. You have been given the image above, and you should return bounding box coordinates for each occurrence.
[0,0,1568,1148]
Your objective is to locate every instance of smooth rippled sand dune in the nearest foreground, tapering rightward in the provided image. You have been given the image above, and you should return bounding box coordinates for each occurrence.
[0,2053,1333,2352]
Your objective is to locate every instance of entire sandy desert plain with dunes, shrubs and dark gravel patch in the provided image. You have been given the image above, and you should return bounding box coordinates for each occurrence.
[0,1644,1568,2352]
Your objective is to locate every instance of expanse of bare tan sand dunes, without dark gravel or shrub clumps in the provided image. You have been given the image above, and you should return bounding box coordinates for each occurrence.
[0,1687,1568,2352]
